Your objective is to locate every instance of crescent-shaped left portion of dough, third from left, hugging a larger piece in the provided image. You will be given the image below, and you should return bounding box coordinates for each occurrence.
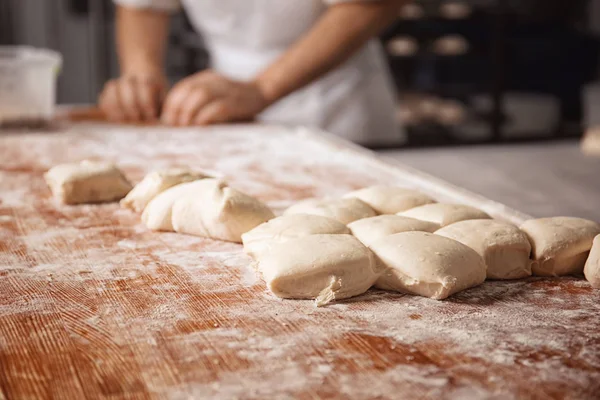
[142,179,220,232]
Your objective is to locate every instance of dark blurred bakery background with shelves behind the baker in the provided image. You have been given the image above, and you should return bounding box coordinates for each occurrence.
[0,0,600,146]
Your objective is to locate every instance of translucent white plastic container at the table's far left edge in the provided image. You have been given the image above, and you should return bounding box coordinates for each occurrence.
[0,46,62,127]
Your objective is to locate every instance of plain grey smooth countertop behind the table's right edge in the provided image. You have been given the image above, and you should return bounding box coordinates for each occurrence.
[381,140,600,222]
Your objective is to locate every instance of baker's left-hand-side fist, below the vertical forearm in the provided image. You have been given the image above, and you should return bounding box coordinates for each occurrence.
[98,75,167,122]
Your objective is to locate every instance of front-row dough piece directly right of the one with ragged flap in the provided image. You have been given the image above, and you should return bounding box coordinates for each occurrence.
[371,232,485,300]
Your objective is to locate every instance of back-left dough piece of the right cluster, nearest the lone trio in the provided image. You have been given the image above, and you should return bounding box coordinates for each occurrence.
[284,198,377,224]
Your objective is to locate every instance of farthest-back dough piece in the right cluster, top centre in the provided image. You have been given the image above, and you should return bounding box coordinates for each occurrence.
[344,185,436,214]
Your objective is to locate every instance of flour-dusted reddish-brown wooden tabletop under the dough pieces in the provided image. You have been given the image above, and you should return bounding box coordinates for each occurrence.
[0,125,600,399]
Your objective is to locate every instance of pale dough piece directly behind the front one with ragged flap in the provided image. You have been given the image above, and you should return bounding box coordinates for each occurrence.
[242,214,350,259]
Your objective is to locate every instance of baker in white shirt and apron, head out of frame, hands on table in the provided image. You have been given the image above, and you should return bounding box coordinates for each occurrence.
[99,0,406,144]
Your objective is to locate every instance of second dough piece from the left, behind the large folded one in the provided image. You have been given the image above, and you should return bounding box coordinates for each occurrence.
[121,168,209,212]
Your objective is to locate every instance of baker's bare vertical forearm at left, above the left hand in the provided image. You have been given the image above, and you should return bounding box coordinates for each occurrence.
[116,6,170,75]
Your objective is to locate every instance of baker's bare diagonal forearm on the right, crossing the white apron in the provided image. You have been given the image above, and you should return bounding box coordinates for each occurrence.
[256,0,408,103]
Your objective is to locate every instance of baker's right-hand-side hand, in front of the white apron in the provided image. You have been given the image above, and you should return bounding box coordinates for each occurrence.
[161,70,269,126]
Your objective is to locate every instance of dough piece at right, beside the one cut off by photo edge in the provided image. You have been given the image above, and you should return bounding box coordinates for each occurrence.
[521,217,600,276]
